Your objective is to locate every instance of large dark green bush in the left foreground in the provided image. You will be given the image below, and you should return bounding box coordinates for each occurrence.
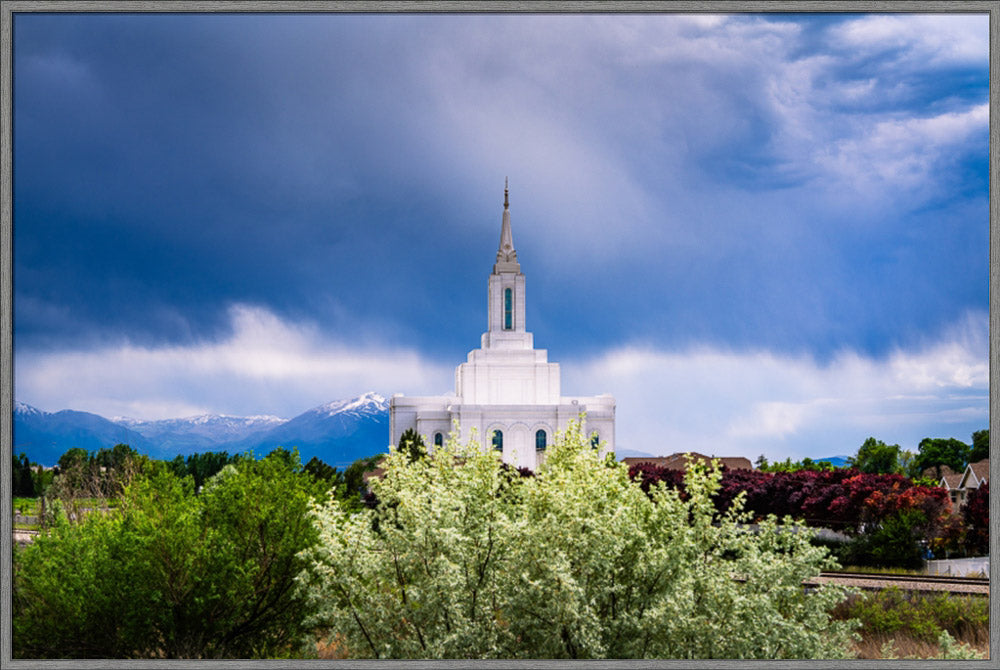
[13,448,325,658]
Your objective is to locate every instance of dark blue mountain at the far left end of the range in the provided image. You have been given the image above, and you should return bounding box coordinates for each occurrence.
[13,402,154,465]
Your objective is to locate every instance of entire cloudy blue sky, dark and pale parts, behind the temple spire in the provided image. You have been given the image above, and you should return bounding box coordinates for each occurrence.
[13,9,990,460]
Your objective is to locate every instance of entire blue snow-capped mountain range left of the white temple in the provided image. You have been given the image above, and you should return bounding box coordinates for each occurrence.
[14,392,389,467]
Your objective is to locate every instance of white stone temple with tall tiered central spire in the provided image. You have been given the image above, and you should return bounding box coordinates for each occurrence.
[390,184,615,469]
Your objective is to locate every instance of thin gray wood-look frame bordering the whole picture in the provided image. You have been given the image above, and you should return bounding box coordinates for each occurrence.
[0,0,1000,670]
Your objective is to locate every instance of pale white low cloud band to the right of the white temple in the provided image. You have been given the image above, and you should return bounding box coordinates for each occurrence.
[563,313,989,459]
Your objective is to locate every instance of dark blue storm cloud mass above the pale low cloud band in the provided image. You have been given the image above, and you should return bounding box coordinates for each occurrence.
[14,14,988,368]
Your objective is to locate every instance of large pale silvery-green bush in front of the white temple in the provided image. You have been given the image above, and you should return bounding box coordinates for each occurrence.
[300,424,851,658]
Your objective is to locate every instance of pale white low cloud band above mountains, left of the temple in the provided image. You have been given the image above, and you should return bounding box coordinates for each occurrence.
[15,305,452,419]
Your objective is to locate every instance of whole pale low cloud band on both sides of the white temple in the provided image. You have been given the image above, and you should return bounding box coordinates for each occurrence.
[16,305,989,459]
